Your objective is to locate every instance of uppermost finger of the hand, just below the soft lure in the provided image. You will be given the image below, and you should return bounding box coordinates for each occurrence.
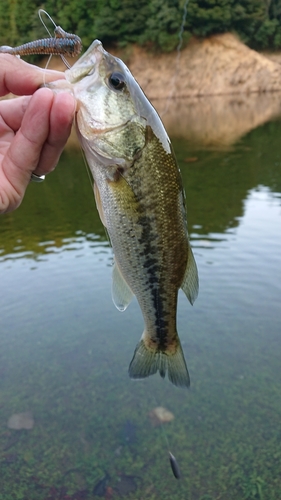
[0,54,65,96]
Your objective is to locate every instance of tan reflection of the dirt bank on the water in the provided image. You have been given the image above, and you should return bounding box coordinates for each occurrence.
[153,92,281,149]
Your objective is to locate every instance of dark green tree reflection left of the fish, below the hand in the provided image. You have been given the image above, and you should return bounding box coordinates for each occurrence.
[0,149,105,256]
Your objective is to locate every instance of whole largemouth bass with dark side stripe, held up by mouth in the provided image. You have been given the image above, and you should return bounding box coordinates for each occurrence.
[48,40,198,387]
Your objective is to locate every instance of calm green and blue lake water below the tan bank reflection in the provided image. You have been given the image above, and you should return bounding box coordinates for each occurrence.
[0,102,281,500]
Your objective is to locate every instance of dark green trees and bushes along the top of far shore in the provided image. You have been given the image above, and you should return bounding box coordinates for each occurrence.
[0,0,281,51]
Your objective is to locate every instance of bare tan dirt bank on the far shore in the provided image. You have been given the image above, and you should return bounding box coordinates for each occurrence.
[129,33,281,99]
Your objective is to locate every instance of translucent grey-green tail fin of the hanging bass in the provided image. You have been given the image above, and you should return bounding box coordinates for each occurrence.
[129,333,190,387]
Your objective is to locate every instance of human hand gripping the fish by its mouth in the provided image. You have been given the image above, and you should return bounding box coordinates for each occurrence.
[0,54,75,213]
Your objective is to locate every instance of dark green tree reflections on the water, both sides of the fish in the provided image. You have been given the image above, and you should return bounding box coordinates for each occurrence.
[0,107,281,259]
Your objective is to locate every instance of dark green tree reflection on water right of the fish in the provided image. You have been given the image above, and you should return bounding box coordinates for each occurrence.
[173,121,281,234]
